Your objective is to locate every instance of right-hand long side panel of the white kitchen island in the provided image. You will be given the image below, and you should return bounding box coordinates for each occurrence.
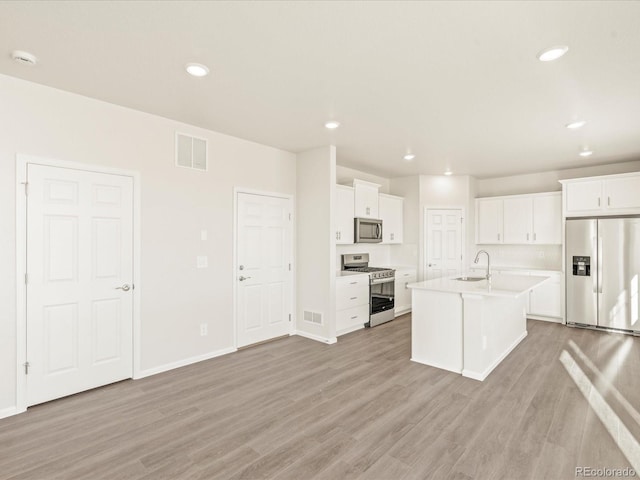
[462,295,527,381]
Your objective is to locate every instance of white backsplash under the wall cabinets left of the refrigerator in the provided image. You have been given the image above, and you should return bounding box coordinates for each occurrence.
[469,245,562,270]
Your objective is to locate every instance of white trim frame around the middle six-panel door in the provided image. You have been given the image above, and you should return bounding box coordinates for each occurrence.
[231,187,296,350]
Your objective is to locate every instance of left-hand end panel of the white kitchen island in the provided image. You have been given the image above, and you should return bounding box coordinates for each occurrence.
[411,289,463,373]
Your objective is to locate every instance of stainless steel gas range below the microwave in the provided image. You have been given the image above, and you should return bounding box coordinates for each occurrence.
[341,253,396,327]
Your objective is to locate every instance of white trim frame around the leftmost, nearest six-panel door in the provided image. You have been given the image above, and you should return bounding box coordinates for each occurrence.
[15,153,142,413]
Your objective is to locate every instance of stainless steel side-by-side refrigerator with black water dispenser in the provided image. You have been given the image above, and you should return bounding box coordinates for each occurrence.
[565,217,640,335]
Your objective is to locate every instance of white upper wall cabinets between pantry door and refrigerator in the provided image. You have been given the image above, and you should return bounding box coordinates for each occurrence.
[476,192,562,245]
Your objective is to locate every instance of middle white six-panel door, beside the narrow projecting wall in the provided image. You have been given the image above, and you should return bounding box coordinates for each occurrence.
[235,193,292,347]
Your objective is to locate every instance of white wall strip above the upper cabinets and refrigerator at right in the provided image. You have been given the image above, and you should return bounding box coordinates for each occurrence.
[477,160,640,197]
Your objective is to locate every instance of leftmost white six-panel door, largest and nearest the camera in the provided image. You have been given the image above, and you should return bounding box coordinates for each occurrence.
[26,164,133,405]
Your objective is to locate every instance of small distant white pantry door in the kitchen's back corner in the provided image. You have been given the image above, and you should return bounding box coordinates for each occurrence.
[425,209,463,280]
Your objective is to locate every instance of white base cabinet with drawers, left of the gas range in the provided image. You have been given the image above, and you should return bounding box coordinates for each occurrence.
[336,273,369,336]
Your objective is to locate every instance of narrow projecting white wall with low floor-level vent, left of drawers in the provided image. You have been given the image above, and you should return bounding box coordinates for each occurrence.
[296,146,336,343]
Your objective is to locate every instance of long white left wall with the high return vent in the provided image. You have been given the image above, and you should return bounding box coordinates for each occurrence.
[0,75,296,411]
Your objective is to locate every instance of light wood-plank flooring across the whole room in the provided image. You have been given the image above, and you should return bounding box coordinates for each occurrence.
[0,315,640,480]
